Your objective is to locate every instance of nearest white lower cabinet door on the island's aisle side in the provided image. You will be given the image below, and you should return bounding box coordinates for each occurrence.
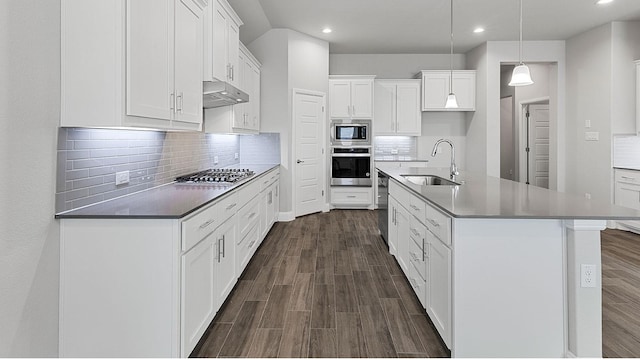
[427,234,451,344]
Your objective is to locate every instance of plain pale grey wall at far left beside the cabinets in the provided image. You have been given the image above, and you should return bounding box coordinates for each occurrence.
[0,0,60,357]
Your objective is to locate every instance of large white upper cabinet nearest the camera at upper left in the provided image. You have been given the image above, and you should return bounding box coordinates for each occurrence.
[60,0,207,130]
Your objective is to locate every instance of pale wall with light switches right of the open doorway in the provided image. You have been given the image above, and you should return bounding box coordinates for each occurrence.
[567,22,640,202]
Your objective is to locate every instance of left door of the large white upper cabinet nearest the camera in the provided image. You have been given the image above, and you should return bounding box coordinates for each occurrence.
[126,0,175,121]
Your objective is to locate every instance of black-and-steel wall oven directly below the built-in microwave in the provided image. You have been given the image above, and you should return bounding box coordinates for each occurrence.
[331,147,372,186]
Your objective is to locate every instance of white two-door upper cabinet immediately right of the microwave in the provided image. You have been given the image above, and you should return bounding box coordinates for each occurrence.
[373,80,422,136]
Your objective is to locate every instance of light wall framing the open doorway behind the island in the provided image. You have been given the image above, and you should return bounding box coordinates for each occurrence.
[466,41,565,191]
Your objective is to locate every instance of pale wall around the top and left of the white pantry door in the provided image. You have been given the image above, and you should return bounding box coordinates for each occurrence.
[247,29,329,217]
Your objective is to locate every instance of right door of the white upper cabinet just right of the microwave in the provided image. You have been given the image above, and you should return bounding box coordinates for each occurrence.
[396,83,422,136]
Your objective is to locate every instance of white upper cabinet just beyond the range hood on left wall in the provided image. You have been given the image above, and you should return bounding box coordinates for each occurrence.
[204,43,261,134]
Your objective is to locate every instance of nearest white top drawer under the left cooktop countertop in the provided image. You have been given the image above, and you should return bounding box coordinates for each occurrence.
[182,192,238,251]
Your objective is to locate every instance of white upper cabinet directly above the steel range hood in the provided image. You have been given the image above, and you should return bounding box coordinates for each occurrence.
[204,0,243,87]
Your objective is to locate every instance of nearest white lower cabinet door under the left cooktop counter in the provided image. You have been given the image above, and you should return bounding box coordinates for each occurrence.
[181,234,217,355]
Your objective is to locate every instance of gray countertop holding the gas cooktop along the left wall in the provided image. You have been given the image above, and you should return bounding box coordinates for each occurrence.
[56,164,280,219]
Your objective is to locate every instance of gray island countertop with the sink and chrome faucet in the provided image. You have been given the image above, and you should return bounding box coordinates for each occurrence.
[376,164,640,220]
